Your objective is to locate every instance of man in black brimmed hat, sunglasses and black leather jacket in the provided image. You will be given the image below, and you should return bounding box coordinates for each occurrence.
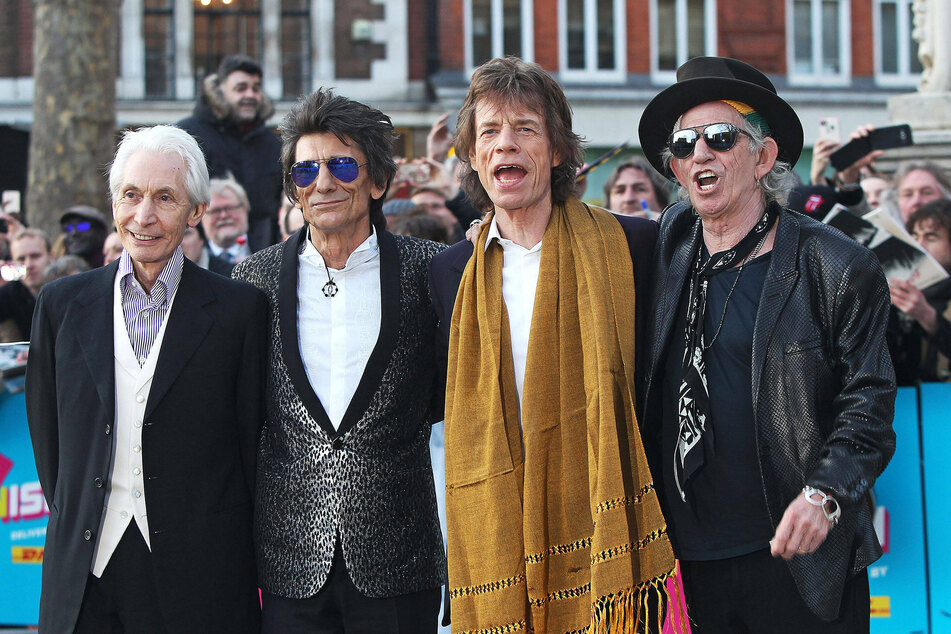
[640,57,895,633]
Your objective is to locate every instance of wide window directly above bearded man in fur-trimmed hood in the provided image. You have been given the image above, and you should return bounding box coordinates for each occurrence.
[194,0,262,84]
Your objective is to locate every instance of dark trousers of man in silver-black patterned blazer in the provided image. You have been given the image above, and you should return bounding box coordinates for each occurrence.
[261,541,440,634]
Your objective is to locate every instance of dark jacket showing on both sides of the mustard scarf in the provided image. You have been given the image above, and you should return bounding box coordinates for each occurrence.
[429,210,658,407]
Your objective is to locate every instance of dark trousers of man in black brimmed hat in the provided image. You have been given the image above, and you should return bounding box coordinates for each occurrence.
[680,548,869,634]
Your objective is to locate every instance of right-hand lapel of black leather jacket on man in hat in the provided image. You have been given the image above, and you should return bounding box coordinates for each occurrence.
[752,210,799,413]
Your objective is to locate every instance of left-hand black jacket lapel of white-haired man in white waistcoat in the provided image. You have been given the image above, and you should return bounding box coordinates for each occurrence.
[75,260,119,410]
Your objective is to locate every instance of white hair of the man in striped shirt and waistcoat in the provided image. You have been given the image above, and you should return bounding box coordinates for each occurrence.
[109,125,211,207]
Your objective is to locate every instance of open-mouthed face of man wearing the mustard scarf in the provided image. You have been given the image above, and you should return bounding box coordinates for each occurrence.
[469,100,561,213]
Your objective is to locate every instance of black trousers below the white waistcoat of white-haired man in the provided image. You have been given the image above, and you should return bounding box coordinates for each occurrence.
[74,522,166,634]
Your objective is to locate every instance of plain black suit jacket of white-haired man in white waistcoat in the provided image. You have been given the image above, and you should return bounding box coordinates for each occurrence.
[26,259,267,633]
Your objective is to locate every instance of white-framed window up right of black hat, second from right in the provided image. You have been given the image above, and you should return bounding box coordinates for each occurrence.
[786,0,852,85]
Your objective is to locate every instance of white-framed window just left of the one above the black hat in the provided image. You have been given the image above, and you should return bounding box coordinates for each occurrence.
[558,0,626,82]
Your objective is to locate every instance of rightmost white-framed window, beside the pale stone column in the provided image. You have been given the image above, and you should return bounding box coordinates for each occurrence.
[873,0,922,86]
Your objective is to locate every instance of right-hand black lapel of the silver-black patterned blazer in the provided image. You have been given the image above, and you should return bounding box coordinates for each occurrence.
[337,231,401,436]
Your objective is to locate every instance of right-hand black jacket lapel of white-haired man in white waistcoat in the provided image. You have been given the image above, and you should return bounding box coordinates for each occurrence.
[145,258,215,418]
